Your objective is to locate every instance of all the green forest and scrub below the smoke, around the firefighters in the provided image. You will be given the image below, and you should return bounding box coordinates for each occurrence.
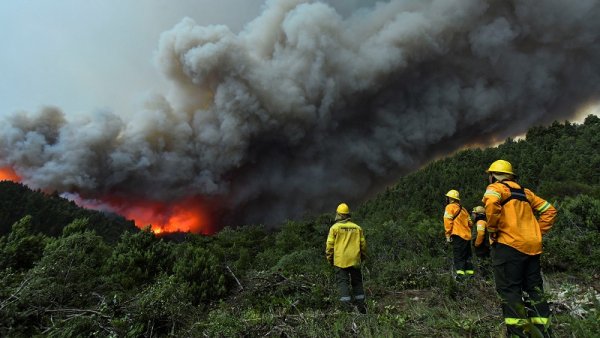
[0,115,600,337]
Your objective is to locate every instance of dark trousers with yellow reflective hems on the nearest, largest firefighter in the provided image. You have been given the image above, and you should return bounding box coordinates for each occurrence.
[492,243,550,337]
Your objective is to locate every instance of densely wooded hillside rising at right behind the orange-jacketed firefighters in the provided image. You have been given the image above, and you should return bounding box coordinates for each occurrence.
[360,115,600,221]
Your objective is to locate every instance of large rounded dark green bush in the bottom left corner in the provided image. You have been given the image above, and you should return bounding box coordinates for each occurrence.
[2,227,110,336]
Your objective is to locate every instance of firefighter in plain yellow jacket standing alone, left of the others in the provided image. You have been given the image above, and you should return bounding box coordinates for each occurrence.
[325,203,367,314]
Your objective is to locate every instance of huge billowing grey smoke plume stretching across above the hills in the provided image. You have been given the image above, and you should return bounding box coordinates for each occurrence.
[0,0,600,224]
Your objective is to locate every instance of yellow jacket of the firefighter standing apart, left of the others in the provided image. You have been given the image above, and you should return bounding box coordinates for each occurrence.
[325,219,367,268]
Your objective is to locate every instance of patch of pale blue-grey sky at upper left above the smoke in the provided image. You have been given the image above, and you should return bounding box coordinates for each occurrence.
[0,0,264,115]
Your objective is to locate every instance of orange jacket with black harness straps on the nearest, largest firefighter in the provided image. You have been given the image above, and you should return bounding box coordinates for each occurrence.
[482,180,556,255]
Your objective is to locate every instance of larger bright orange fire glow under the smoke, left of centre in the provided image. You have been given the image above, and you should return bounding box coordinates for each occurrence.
[105,197,214,235]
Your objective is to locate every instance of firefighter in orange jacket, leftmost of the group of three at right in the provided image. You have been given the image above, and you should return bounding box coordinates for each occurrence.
[444,190,474,279]
